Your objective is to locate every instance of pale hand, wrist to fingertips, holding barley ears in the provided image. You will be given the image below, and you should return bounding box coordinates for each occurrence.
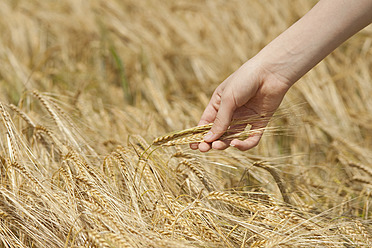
[190,59,291,152]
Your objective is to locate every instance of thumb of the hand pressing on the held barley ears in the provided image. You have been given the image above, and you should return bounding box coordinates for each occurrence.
[204,94,236,143]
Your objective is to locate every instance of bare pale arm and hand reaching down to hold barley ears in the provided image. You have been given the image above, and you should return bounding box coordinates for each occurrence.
[190,0,372,152]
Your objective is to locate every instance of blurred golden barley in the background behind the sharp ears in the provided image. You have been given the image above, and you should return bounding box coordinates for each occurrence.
[0,0,372,246]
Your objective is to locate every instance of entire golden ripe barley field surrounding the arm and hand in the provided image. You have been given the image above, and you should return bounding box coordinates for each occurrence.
[0,0,372,248]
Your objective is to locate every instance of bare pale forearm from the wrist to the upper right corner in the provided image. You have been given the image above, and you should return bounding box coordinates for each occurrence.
[255,0,372,85]
